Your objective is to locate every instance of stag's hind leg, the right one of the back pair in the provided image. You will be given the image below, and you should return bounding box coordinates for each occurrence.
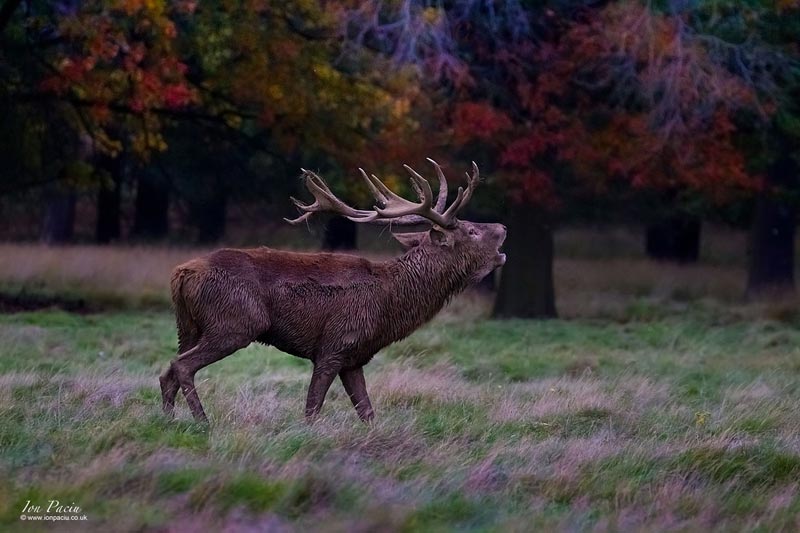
[170,334,252,423]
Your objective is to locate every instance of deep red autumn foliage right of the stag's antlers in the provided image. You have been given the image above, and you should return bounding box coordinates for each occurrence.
[440,3,758,206]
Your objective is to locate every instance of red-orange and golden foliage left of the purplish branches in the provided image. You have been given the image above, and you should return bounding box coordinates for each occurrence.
[18,0,407,164]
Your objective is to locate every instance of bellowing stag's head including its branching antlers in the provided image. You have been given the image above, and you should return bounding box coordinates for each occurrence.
[286,158,506,281]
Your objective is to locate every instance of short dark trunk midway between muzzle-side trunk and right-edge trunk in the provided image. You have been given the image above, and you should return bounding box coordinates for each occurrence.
[645,214,702,263]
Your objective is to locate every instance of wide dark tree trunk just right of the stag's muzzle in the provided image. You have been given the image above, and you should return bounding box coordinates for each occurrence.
[493,205,557,318]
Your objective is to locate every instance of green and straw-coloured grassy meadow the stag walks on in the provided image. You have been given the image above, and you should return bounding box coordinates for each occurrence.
[0,239,800,531]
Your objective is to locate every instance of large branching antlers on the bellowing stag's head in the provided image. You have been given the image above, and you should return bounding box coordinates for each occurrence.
[285,158,479,228]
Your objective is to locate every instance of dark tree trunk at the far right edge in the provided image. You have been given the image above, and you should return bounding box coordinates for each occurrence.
[747,157,798,298]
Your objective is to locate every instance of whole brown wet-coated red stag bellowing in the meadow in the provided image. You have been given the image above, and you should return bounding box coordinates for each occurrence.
[160,158,506,424]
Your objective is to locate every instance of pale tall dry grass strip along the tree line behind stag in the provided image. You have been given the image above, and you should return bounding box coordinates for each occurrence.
[0,220,797,319]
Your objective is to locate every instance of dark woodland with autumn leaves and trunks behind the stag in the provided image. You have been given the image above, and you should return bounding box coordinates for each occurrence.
[0,0,800,317]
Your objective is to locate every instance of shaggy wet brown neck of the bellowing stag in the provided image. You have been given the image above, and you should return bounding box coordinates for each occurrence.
[386,246,470,338]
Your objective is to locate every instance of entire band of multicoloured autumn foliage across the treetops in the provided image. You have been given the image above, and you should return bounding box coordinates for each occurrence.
[3,0,798,210]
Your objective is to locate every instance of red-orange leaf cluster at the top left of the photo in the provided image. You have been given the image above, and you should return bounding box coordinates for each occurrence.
[33,0,199,155]
